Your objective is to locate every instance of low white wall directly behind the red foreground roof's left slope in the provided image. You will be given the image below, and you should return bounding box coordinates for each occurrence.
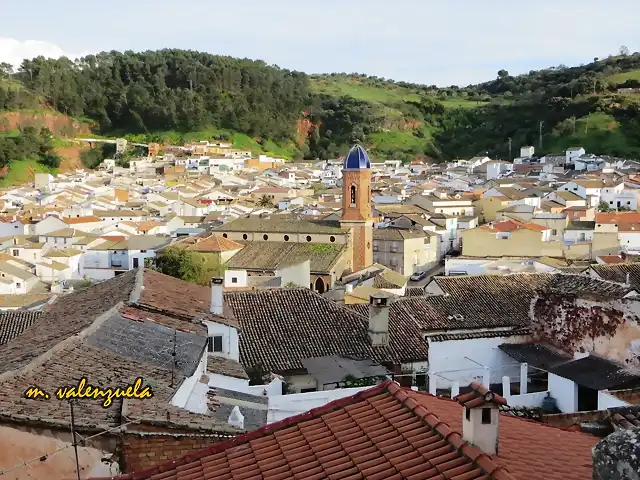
[267,387,371,423]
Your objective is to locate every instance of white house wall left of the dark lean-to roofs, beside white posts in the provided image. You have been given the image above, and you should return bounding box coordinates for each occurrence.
[428,337,524,388]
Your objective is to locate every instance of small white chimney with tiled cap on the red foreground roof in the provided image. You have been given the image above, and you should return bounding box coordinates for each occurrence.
[455,382,507,455]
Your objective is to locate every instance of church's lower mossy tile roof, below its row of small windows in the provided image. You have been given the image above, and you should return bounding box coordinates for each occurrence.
[226,242,347,273]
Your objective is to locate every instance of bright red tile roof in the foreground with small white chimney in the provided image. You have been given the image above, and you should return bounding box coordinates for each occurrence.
[96,381,598,480]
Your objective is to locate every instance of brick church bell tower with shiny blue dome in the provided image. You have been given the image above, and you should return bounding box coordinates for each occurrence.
[340,145,373,272]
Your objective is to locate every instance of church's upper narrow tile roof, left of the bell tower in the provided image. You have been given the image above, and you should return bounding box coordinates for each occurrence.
[215,217,346,235]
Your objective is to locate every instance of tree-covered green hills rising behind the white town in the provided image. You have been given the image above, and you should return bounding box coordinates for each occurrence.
[0,49,640,163]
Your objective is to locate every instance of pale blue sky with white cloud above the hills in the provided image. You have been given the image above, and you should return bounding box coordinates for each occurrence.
[0,0,640,86]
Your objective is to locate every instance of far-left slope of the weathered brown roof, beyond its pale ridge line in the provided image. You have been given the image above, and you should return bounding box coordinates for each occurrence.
[0,270,136,374]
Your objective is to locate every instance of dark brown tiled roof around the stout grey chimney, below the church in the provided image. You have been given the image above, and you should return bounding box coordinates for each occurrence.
[225,288,428,372]
